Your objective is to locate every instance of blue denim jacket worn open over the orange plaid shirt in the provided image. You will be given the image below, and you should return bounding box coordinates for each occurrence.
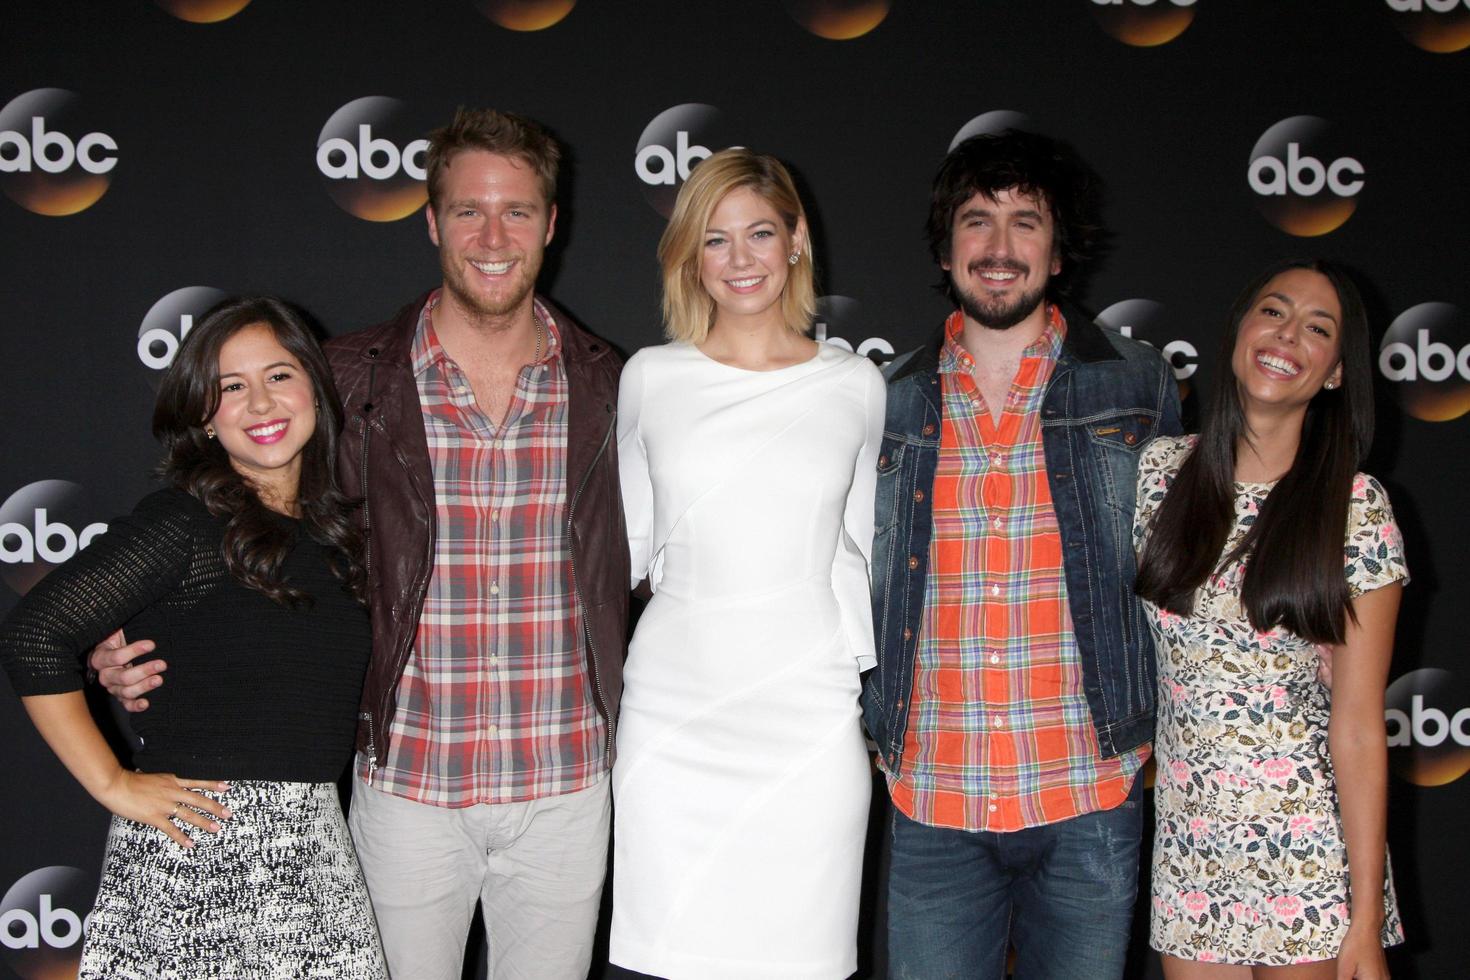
[863,304,1180,768]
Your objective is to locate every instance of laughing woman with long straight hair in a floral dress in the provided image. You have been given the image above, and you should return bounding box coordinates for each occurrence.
[1135,262,1408,980]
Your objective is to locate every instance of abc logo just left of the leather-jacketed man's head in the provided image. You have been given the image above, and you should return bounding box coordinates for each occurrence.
[316,96,429,222]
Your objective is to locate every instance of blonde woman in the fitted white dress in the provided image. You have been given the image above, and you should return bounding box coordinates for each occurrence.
[610,148,883,980]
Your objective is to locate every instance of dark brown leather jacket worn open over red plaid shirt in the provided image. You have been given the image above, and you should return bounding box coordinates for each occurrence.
[326,294,628,771]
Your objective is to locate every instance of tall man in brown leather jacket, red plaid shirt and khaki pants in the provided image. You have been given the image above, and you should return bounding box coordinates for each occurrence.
[93,109,629,980]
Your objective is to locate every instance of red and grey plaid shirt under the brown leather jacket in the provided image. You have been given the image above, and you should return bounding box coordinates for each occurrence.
[365,294,607,807]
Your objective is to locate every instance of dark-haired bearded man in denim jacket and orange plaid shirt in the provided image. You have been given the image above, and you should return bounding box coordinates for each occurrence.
[864,131,1180,980]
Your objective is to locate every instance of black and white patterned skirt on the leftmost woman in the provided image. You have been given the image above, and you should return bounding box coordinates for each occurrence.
[78,780,388,980]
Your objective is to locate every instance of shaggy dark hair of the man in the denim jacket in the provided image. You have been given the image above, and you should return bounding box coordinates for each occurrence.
[926,129,1105,298]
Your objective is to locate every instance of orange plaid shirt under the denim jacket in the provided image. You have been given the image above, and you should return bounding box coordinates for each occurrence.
[889,306,1148,832]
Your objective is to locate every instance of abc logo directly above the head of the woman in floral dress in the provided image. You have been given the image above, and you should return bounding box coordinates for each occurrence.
[1247,116,1364,238]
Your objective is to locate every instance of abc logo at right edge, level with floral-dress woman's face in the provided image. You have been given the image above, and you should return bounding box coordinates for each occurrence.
[1379,303,1470,422]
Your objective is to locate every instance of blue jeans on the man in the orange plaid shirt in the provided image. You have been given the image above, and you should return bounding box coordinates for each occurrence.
[888,777,1144,980]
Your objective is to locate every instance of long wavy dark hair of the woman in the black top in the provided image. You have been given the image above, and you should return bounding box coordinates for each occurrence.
[153,297,368,605]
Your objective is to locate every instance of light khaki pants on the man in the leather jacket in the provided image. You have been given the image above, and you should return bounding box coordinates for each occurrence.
[348,779,610,980]
